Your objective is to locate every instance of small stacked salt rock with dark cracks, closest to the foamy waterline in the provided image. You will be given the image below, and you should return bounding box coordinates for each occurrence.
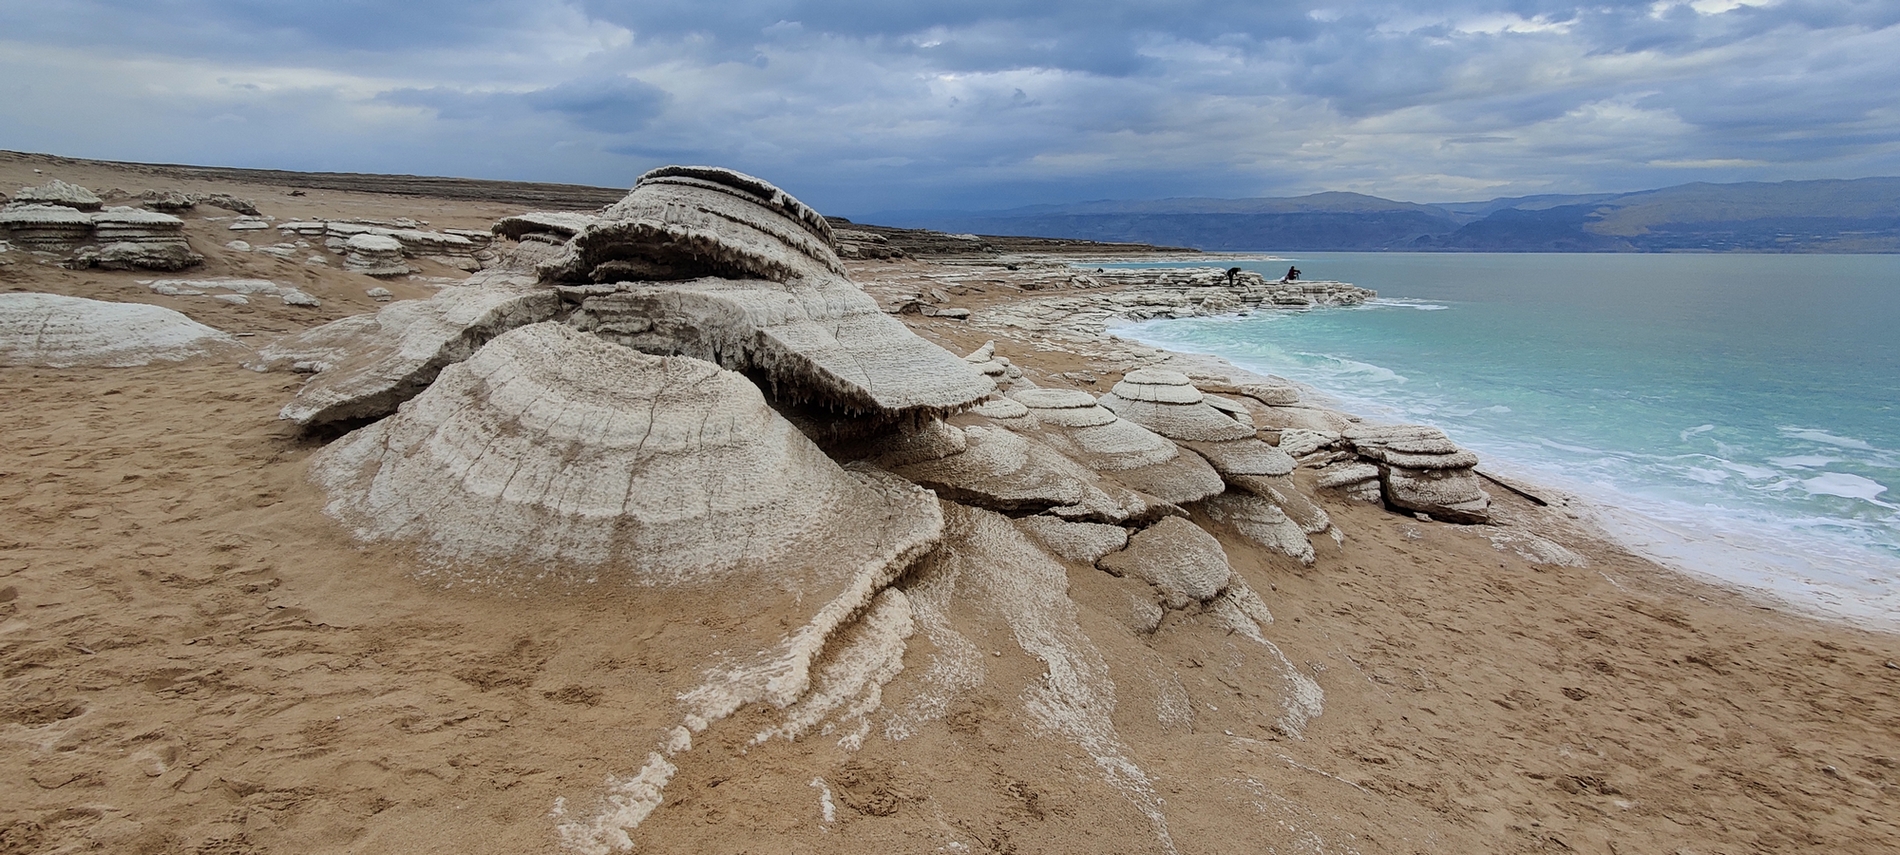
[1341,424,1492,524]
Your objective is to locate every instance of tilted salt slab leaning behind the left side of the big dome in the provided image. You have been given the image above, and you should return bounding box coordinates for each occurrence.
[247,272,561,428]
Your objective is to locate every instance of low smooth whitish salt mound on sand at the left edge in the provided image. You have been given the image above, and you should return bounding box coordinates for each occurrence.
[0,295,238,369]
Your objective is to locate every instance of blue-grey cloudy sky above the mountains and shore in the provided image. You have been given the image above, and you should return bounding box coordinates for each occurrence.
[0,0,1900,217]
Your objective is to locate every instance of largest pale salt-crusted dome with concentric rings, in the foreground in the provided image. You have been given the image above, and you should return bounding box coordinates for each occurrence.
[312,323,942,599]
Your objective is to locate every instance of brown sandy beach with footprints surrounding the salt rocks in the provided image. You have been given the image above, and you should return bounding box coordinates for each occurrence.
[0,154,1900,855]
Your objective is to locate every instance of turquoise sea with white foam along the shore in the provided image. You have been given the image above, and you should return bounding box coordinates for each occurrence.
[1113,253,1900,631]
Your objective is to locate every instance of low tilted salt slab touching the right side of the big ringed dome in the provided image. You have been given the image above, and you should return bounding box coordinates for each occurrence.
[876,426,1178,523]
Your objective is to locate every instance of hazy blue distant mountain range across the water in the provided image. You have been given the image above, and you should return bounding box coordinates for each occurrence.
[865,179,1900,253]
